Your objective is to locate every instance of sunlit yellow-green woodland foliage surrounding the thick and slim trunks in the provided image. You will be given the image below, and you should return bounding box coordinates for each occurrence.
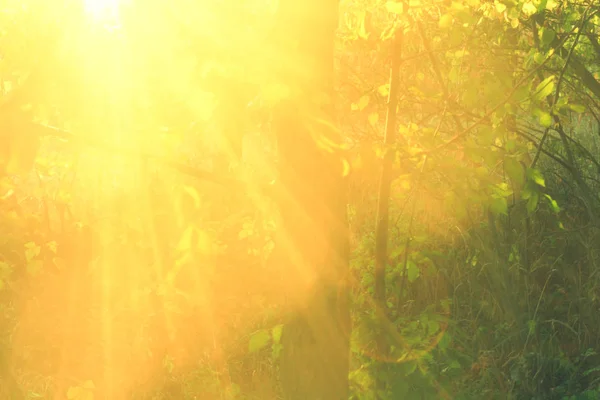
[0,0,600,399]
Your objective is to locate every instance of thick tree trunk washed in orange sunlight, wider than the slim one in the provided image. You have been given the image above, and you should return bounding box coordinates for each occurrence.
[273,0,350,400]
